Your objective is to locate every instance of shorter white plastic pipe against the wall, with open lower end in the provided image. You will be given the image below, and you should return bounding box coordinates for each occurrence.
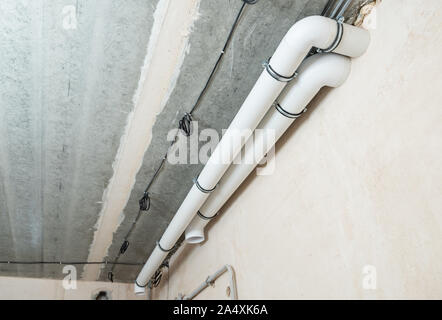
[186,54,351,243]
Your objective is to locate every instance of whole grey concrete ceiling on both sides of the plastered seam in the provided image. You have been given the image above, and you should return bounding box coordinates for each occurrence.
[0,0,361,282]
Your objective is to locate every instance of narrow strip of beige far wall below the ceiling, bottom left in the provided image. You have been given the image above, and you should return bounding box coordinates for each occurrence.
[0,277,146,300]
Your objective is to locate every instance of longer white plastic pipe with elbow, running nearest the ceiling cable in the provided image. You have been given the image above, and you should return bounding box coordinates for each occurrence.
[135,16,370,287]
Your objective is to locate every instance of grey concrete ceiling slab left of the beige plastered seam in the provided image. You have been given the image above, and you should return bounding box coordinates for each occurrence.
[0,0,156,278]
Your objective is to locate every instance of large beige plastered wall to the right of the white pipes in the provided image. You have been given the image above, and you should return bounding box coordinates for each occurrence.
[154,0,442,299]
